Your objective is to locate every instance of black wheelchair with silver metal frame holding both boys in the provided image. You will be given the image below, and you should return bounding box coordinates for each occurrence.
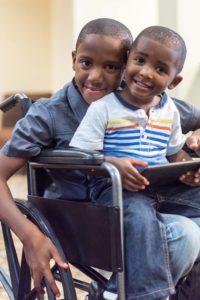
[0,94,125,300]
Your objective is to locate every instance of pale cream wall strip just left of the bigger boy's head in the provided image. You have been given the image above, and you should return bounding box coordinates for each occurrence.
[51,0,74,91]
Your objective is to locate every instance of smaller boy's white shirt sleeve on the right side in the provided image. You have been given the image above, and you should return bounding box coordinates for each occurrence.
[167,110,185,156]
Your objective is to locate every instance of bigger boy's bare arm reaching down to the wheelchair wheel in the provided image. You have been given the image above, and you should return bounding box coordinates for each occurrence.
[0,153,67,295]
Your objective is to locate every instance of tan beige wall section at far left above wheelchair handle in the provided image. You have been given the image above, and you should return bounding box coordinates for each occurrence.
[0,0,51,95]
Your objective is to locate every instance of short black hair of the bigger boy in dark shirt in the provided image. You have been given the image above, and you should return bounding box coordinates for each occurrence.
[76,18,133,51]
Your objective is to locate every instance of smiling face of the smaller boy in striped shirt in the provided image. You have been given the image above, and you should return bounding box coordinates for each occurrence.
[122,36,182,105]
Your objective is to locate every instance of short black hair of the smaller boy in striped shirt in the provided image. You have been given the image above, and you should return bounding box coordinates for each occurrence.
[131,26,187,73]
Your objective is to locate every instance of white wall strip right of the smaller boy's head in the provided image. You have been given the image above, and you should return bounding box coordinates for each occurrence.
[177,0,200,103]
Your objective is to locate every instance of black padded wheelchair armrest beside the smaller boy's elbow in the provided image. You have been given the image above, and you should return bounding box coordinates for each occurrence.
[31,147,104,165]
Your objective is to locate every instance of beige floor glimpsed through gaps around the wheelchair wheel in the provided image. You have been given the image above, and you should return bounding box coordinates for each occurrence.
[0,175,90,300]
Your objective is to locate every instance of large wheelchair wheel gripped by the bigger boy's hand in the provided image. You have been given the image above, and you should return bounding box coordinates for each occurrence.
[0,200,77,300]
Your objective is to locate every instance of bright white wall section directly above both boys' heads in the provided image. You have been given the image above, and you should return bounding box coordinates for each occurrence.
[73,0,158,41]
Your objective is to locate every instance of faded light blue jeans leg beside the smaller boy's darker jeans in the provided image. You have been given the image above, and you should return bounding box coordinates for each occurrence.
[162,214,200,285]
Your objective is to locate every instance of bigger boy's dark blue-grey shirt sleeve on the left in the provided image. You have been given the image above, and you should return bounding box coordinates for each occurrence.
[1,100,53,158]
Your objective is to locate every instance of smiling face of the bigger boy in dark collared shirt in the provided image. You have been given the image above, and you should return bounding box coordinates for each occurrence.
[72,34,126,104]
